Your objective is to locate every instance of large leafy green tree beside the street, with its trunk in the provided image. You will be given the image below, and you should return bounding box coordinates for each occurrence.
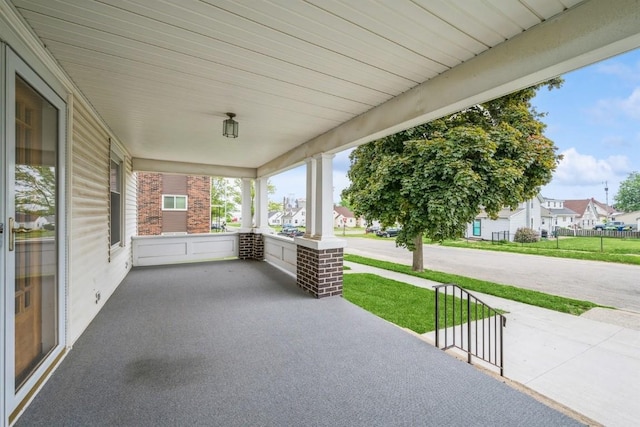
[342,79,562,271]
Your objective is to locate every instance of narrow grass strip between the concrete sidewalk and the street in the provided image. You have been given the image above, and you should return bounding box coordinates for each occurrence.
[344,254,601,316]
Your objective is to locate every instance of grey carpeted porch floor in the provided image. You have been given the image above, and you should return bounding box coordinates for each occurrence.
[17,261,579,426]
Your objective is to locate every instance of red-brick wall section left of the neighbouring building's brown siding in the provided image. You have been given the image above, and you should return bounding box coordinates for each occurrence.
[137,172,162,236]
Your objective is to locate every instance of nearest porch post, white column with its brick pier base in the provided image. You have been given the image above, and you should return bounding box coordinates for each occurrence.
[295,153,346,298]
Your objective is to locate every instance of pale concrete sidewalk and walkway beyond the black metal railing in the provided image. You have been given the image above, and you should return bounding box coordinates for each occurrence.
[345,262,640,426]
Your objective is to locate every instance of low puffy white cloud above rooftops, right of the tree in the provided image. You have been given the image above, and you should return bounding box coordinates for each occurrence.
[553,147,632,186]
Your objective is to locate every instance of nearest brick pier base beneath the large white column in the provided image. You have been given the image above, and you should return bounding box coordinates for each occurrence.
[296,245,344,298]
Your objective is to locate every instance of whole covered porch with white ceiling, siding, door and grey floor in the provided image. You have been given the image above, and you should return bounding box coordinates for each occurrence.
[0,0,640,426]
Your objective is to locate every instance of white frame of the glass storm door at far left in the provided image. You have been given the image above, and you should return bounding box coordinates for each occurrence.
[0,43,67,425]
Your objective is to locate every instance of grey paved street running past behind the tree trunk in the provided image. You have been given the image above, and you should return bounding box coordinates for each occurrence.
[345,237,640,313]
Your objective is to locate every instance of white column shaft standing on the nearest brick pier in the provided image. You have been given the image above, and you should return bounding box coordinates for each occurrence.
[313,153,335,240]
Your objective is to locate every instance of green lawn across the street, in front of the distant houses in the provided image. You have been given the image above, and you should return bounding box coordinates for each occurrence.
[441,237,640,265]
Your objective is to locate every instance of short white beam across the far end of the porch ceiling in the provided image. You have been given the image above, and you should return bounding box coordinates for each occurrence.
[132,157,256,179]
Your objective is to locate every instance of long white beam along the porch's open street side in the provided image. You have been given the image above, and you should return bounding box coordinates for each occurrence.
[257,0,640,177]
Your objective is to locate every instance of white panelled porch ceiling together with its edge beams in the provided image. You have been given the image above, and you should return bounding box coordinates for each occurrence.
[10,0,640,176]
